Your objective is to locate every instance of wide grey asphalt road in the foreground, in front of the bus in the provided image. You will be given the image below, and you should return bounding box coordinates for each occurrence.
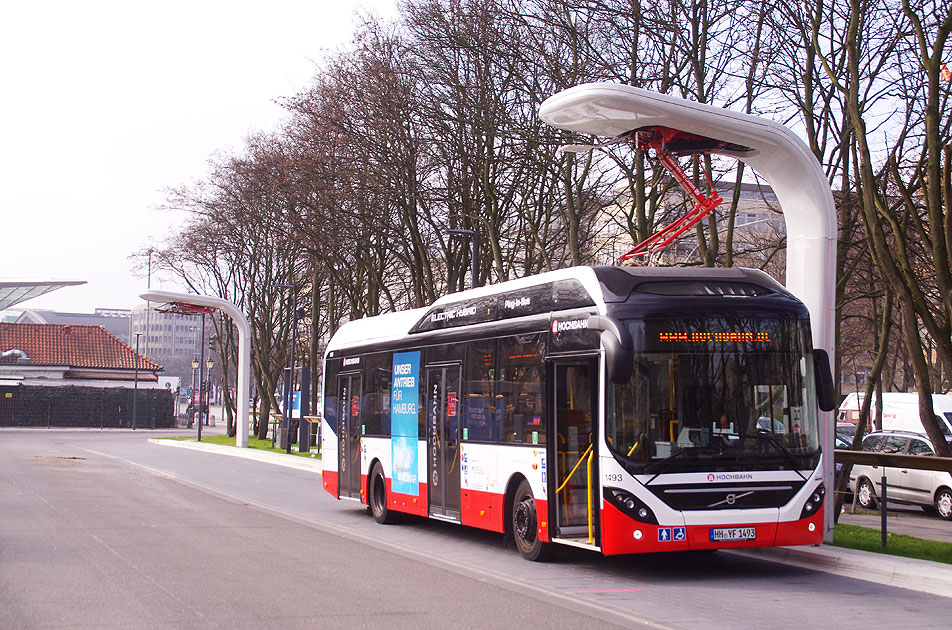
[0,430,949,630]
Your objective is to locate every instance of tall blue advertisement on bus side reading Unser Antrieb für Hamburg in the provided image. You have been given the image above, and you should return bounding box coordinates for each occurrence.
[390,352,420,496]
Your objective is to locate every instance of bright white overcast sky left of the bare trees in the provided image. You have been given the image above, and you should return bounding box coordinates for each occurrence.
[0,0,396,312]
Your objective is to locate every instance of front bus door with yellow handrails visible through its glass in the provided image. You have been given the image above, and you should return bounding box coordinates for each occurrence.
[549,359,601,544]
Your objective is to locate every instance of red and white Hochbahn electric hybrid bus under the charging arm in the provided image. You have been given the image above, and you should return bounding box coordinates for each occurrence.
[323,267,832,560]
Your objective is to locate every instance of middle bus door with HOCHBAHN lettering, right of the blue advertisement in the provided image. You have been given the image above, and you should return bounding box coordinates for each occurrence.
[426,364,460,519]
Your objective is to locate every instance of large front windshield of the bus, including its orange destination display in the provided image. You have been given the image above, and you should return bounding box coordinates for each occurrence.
[605,317,819,474]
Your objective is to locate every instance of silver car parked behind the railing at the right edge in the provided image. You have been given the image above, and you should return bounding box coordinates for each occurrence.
[850,431,952,521]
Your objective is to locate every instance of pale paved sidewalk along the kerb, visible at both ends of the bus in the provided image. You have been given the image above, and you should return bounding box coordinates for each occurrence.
[156,438,952,597]
